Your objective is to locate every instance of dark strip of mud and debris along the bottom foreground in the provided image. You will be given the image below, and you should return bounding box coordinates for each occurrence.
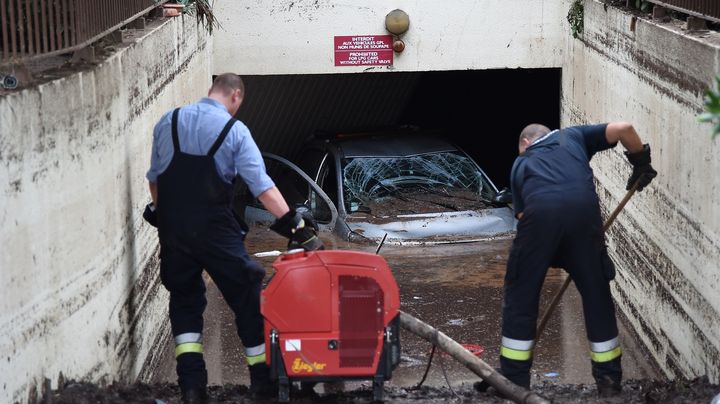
[45,377,720,404]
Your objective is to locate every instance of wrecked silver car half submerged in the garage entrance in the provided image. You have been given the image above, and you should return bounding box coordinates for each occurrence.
[245,134,517,244]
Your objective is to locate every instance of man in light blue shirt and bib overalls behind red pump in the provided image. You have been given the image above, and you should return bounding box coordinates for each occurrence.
[144,74,324,403]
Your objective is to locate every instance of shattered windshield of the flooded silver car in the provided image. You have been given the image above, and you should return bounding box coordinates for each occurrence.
[343,152,496,216]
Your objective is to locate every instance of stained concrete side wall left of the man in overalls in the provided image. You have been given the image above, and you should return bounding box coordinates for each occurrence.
[0,18,212,403]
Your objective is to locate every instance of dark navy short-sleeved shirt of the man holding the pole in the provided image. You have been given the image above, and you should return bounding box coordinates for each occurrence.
[510,124,615,216]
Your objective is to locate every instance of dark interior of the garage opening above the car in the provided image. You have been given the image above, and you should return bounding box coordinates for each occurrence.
[238,69,561,188]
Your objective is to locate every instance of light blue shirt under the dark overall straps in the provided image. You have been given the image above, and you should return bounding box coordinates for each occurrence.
[146,97,275,197]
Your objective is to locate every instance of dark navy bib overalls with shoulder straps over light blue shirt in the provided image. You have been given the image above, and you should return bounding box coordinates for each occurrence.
[157,109,265,391]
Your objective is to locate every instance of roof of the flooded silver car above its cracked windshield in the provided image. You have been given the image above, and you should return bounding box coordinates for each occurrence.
[335,135,458,158]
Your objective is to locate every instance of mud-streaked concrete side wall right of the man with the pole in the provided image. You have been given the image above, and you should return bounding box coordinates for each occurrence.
[562,0,720,382]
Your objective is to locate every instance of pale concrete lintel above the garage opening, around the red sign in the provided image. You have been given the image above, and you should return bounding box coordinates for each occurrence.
[214,0,567,74]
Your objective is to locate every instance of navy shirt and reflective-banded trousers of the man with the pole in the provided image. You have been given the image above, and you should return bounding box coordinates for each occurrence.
[500,125,622,387]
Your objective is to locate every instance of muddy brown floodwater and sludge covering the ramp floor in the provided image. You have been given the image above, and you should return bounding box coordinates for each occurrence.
[43,229,720,404]
